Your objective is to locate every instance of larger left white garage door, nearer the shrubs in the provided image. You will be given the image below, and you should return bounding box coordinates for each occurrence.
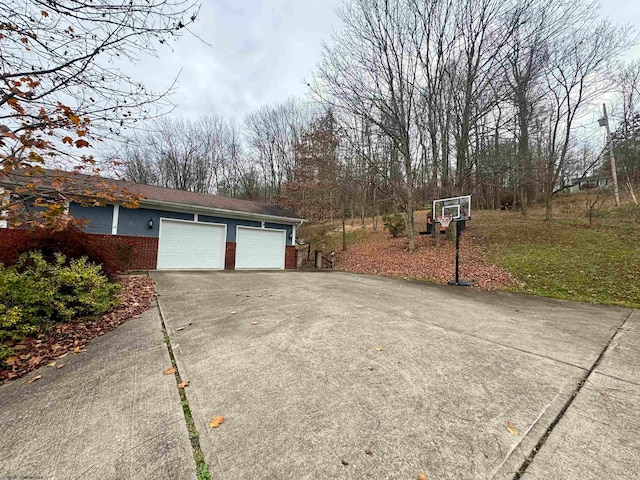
[158,218,227,270]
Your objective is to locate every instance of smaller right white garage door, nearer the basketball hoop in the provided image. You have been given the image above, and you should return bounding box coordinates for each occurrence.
[236,227,286,270]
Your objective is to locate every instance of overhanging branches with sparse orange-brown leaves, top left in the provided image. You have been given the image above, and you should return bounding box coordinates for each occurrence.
[0,0,197,226]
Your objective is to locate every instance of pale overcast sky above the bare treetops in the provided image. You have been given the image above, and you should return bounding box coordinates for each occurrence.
[127,0,640,124]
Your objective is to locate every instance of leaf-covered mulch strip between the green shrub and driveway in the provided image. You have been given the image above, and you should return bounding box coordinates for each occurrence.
[0,276,156,384]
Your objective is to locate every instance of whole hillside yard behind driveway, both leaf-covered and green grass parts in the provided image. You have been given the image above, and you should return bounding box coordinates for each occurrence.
[304,193,640,308]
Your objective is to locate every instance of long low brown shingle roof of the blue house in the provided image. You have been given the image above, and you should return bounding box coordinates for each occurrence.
[0,170,303,222]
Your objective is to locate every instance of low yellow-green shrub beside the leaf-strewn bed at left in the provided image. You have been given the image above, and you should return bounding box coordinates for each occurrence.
[0,252,121,341]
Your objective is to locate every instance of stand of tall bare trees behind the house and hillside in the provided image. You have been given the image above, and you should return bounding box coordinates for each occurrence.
[114,0,640,249]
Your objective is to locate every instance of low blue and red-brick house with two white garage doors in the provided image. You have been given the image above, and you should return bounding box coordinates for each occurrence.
[0,171,304,270]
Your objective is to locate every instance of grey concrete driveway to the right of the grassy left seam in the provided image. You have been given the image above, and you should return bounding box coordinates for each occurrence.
[153,272,640,480]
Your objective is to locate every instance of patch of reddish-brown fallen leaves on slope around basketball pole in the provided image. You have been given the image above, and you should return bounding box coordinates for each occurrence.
[336,231,515,290]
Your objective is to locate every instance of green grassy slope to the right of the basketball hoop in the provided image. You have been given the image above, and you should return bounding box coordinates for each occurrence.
[471,195,640,308]
